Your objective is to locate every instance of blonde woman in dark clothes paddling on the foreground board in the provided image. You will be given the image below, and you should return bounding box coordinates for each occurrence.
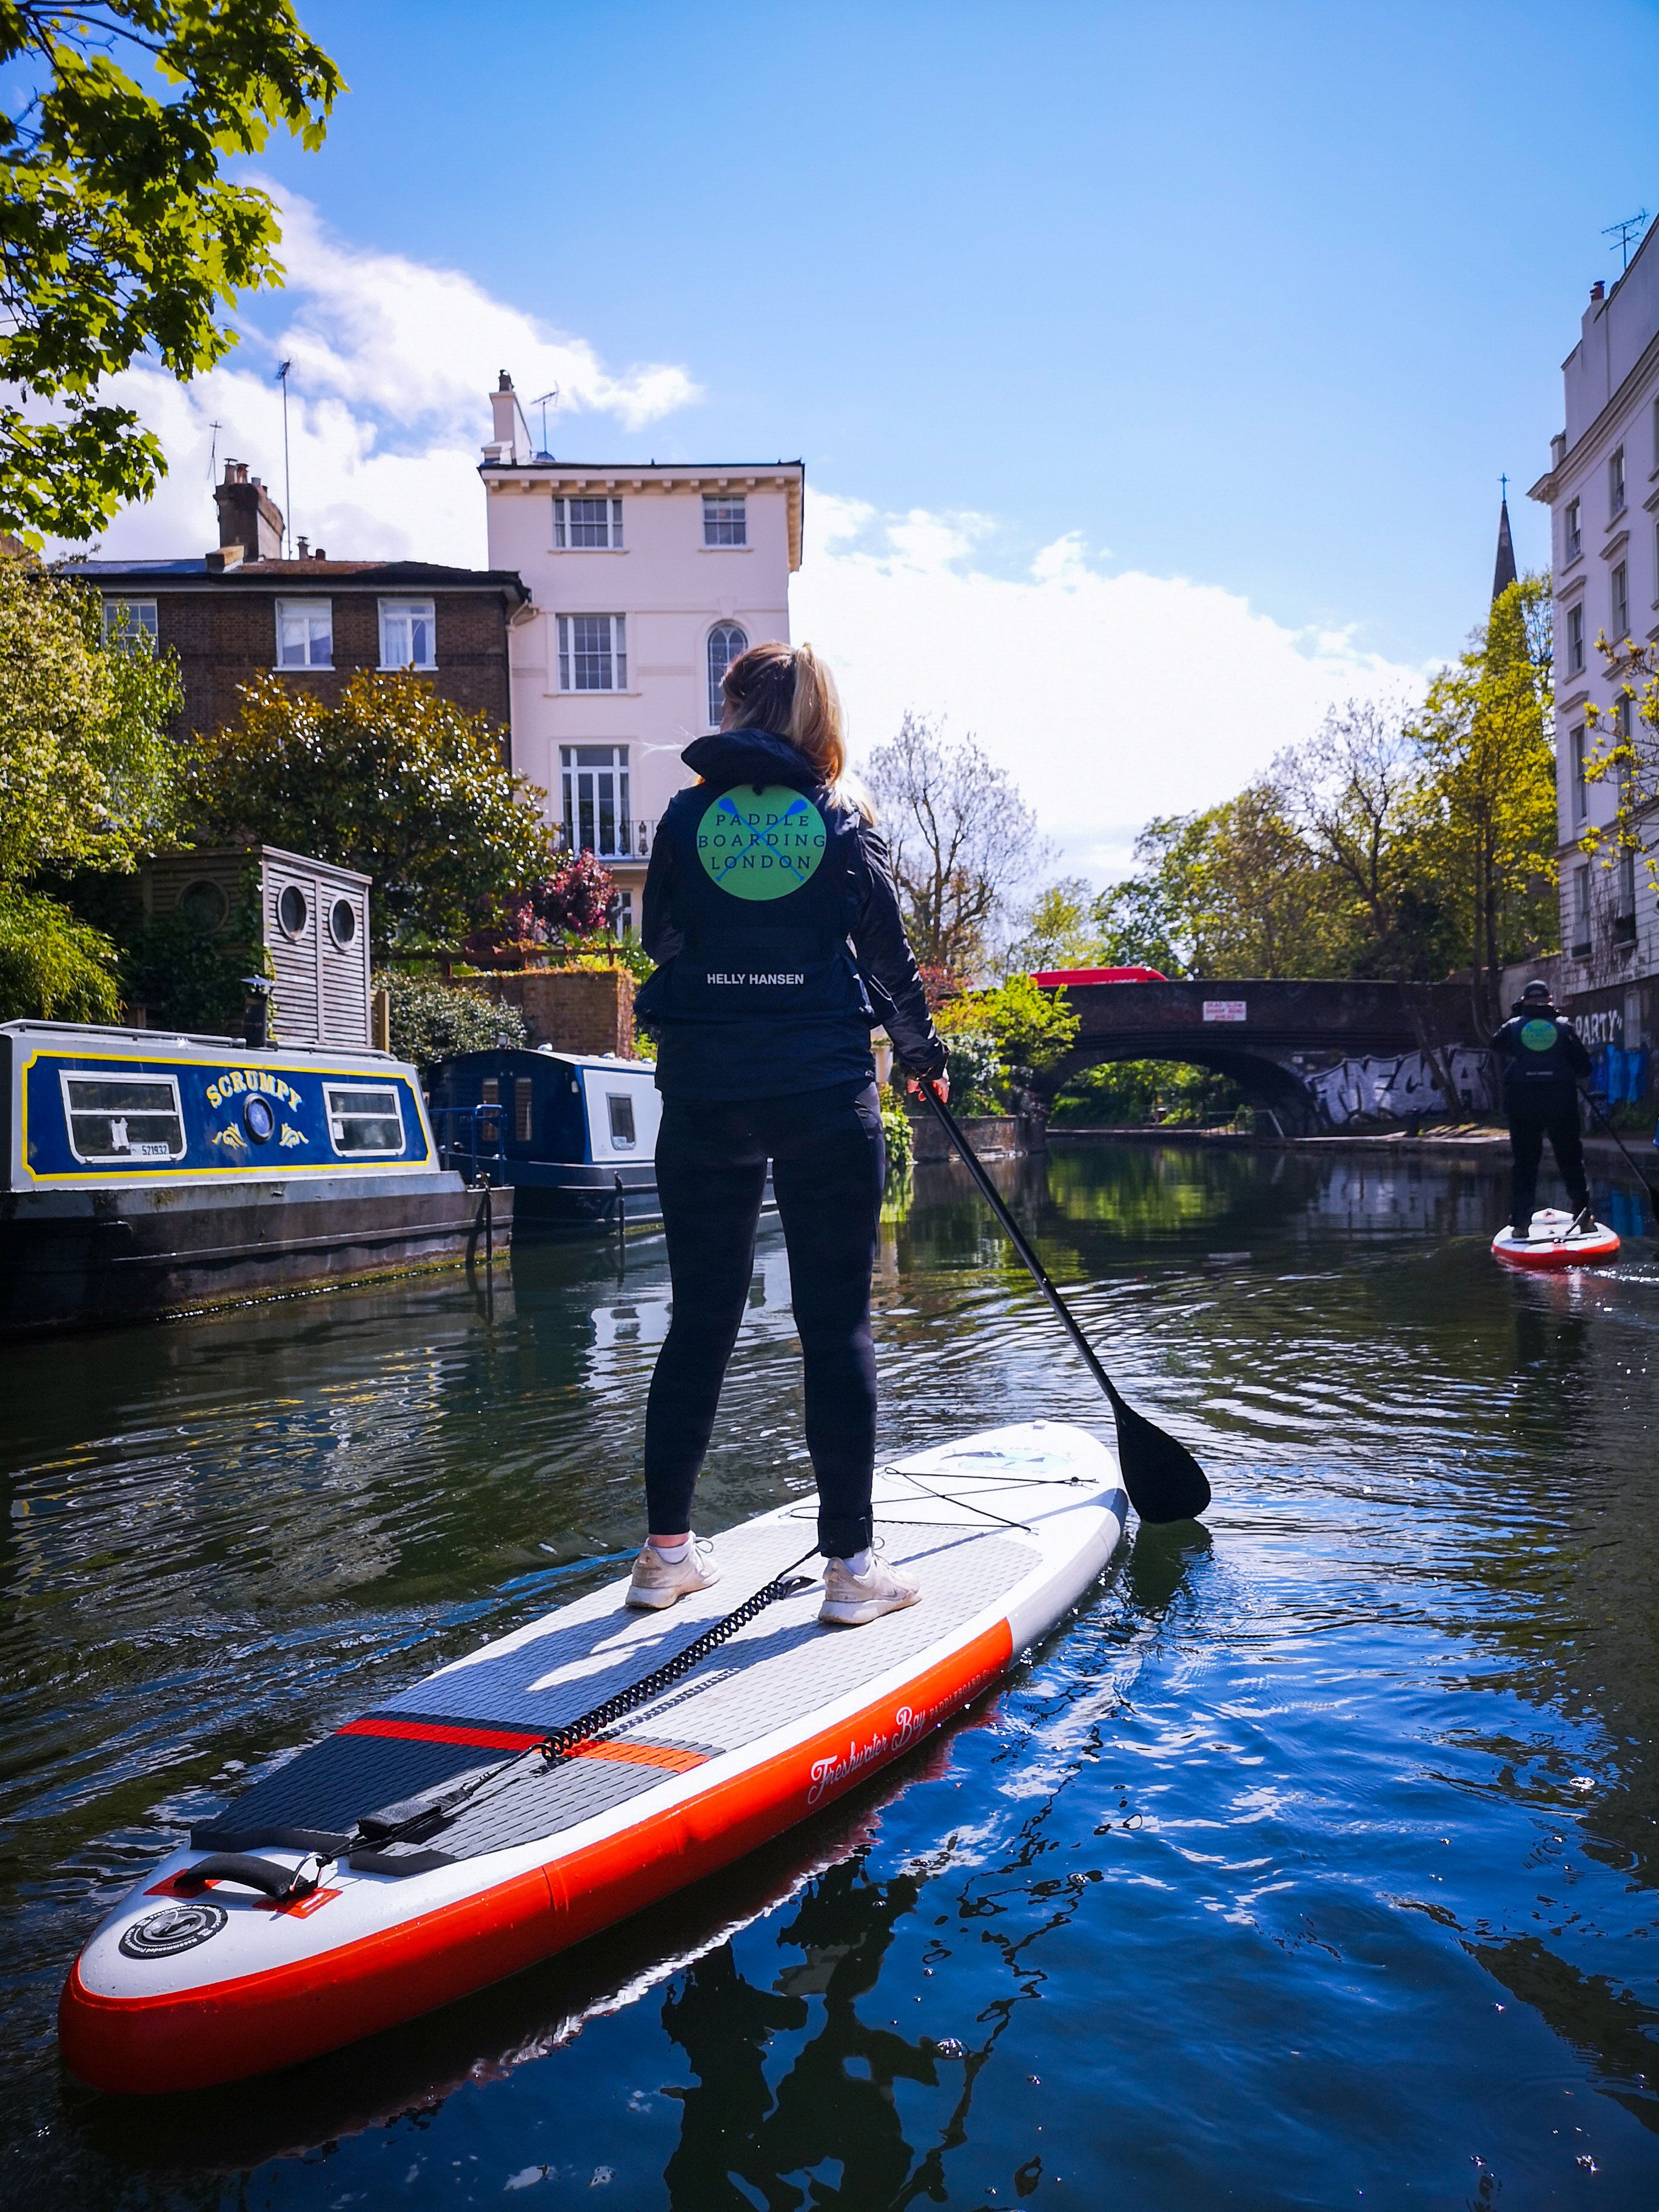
[628,644,949,1626]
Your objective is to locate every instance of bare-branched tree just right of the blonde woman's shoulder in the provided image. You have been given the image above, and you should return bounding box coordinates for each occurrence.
[865,712,1044,976]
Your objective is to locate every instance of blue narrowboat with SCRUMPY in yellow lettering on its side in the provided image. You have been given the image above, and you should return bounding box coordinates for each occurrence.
[0,1022,511,1334]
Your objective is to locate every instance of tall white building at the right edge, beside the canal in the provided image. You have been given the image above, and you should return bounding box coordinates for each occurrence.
[1530,223,1659,1004]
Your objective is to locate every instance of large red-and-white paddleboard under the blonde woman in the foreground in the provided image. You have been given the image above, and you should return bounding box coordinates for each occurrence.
[58,1423,1128,2093]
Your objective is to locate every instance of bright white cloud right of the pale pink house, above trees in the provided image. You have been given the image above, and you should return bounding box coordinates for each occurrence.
[792,494,1423,883]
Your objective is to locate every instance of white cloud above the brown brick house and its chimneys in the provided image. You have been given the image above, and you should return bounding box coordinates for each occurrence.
[52,195,699,566]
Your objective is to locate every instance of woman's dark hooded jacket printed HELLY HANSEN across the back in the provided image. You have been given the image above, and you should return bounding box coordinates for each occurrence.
[637,730,945,1099]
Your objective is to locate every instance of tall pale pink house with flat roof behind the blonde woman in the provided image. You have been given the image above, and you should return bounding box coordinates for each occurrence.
[478,369,805,929]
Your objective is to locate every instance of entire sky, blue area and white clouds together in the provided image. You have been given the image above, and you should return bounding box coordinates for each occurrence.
[75,0,1659,878]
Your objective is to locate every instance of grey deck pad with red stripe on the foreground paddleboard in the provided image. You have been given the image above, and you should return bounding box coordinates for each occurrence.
[192,1515,1040,1871]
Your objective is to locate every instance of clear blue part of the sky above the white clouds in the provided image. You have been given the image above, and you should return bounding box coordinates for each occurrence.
[243,0,1659,662]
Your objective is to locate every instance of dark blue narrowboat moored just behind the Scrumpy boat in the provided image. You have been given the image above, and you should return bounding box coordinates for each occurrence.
[431,1044,662,1230]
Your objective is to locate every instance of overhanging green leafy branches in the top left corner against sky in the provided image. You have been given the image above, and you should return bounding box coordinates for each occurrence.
[0,0,343,546]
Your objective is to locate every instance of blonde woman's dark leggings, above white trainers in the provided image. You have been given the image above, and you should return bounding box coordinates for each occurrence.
[646,1084,887,1560]
